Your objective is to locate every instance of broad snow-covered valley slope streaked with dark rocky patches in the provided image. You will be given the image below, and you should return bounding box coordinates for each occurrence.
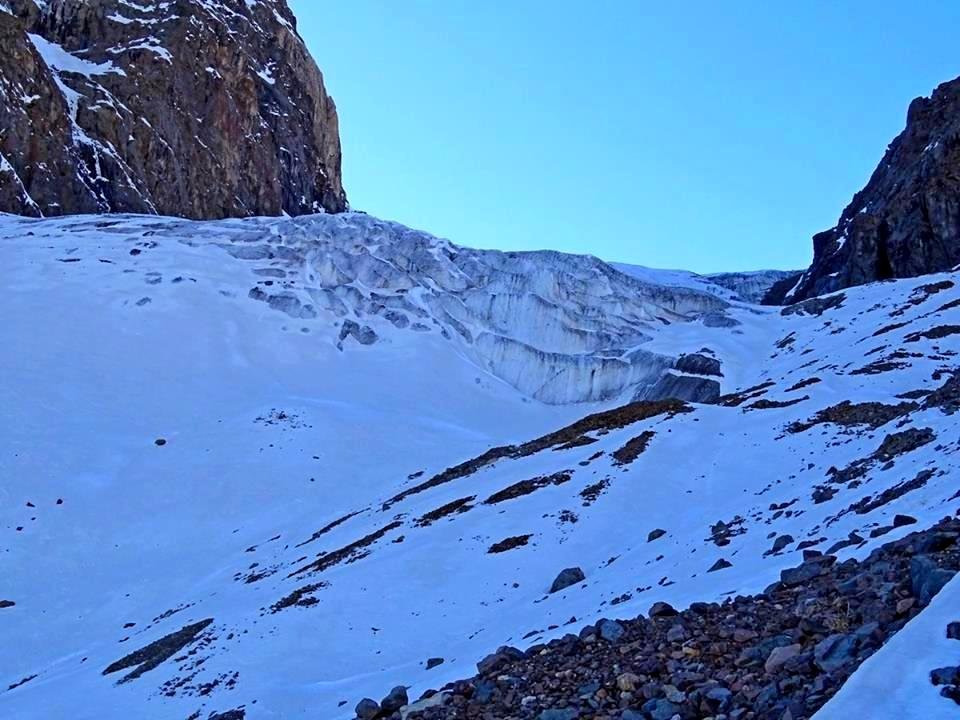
[0,215,960,719]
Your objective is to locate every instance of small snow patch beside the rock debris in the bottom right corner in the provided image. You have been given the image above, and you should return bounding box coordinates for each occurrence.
[816,577,960,720]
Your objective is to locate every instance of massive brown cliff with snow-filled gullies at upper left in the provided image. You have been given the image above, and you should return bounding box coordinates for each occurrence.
[0,0,347,218]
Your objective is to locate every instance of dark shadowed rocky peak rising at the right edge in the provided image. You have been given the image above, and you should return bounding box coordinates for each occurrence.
[786,78,960,302]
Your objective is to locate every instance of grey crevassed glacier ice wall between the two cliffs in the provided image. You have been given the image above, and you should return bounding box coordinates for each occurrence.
[214,213,728,403]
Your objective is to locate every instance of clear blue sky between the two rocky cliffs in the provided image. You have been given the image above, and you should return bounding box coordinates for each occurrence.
[290,0,960,272]
